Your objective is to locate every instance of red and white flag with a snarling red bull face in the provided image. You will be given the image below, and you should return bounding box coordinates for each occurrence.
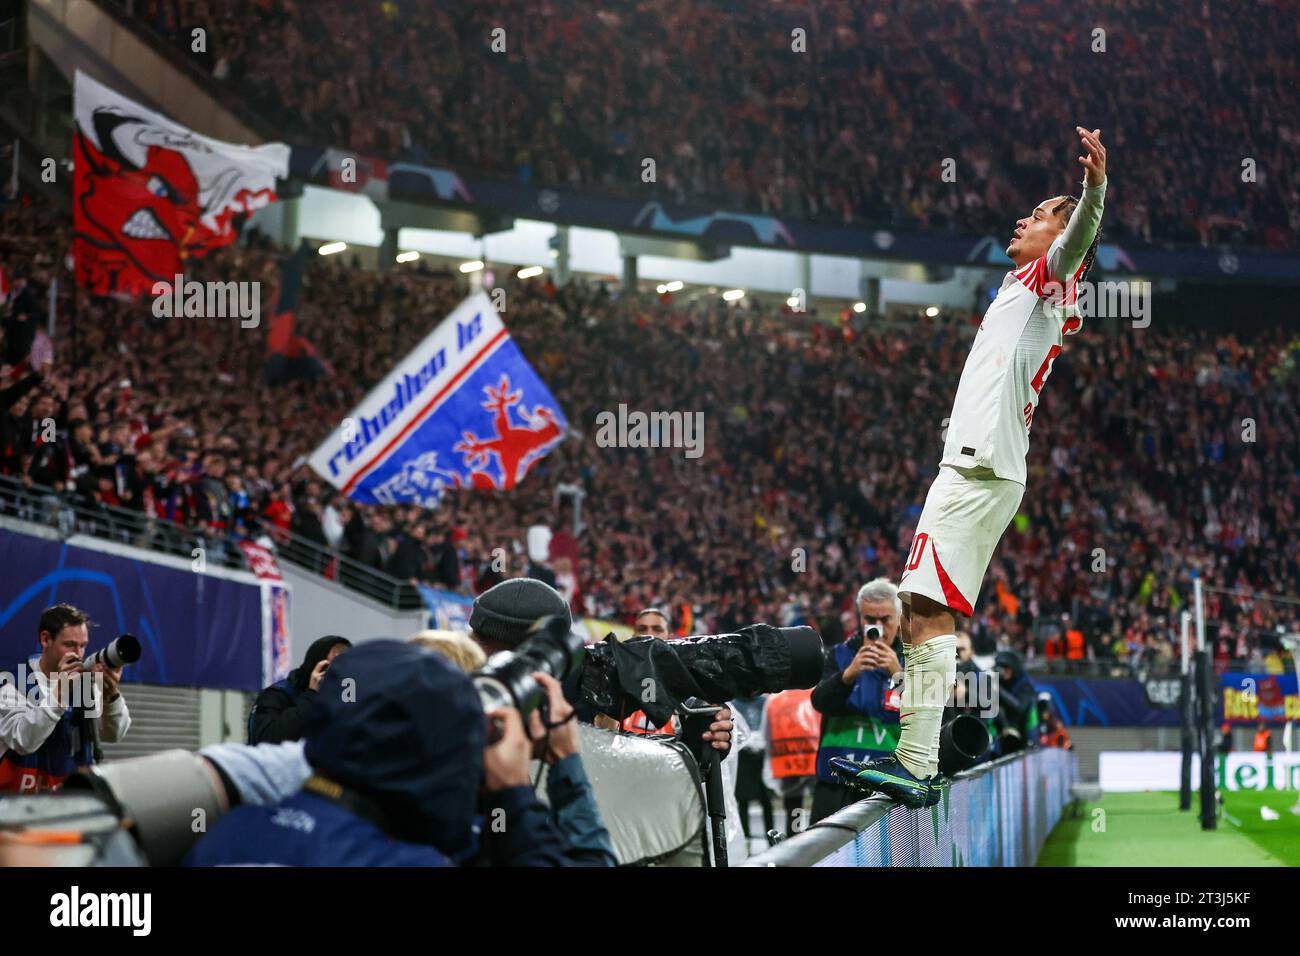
[73,70,289,295]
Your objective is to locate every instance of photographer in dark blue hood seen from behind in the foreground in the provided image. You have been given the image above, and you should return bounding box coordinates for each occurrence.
[186,640,579,866]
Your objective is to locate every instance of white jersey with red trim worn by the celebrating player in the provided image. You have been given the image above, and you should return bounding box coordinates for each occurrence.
[940,233,1083,485]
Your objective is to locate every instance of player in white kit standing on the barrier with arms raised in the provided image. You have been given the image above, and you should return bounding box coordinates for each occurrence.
[831,126,1106,806]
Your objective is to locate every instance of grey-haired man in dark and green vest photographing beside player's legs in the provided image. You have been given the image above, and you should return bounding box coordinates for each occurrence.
[811,578,902,823]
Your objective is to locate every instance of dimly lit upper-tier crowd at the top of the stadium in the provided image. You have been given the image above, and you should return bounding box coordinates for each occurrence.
[120,0,1300,248]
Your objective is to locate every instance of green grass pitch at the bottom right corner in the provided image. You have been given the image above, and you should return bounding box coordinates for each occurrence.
[1039,791,1300,866]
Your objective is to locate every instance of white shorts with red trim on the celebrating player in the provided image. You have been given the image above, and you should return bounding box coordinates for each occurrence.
[898,466,1024,617]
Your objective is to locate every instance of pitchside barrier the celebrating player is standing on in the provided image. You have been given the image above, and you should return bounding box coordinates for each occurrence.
[745,747,1078,866]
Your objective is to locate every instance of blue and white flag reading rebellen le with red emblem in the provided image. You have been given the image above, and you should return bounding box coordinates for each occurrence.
[308,293,568,507]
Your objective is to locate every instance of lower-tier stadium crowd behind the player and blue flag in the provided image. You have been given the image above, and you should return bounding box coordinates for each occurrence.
[0,198,1300,662]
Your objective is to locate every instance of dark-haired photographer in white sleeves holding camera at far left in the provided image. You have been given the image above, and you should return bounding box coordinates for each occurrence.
[0,604,131,792]
